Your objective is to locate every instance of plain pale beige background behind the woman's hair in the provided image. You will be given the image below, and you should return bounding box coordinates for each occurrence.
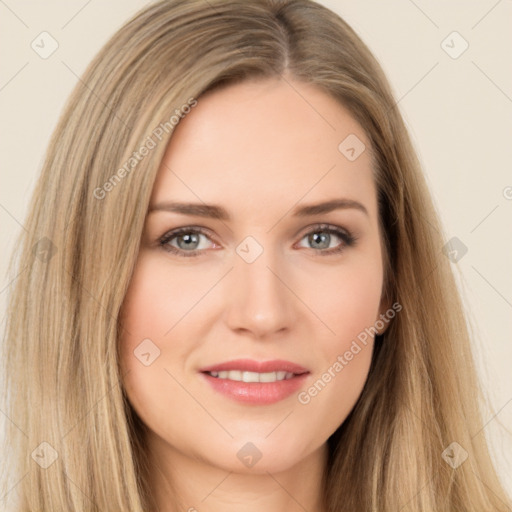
[0,0,512,494]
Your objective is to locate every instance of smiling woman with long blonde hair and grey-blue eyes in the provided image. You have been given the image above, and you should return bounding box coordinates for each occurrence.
[4,0,512,512]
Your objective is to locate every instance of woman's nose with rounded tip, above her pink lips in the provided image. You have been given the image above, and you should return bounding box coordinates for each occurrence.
[225,245,299,338]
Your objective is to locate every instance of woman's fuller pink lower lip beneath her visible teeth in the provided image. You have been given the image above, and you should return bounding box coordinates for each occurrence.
[201,373,308,405]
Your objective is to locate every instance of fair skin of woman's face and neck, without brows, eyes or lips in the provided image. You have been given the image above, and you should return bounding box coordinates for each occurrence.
[120,77,388,512]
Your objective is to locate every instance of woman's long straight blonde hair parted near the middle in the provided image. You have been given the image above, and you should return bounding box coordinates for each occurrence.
[2,0,512,512]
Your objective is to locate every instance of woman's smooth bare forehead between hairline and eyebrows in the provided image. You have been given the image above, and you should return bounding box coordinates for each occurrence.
[152,79,376,214]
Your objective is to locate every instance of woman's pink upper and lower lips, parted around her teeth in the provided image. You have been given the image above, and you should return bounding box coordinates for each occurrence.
[200,359,309,405]
